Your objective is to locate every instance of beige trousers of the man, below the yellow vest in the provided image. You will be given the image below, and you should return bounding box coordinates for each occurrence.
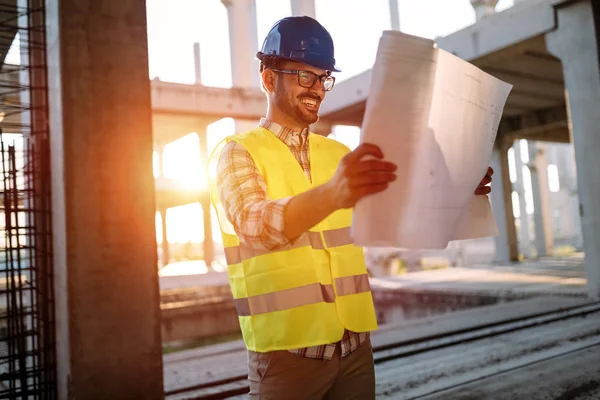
[248,340,375,400]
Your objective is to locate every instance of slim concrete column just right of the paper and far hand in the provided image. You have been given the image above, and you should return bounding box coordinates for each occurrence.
[491,138,519,263]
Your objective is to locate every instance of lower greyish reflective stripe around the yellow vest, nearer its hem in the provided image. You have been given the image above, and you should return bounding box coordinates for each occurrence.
[234,274,371,317]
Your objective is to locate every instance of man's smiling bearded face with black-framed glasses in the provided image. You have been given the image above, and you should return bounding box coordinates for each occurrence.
[273,61,326,125]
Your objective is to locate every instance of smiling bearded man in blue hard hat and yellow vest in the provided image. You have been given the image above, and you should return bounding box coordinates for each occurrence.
[211,17,492,400]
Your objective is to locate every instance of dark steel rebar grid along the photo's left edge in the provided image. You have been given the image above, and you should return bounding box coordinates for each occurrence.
[0,0,57,399]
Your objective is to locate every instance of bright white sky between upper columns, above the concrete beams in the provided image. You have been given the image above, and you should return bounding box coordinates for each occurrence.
[146,0,513,87]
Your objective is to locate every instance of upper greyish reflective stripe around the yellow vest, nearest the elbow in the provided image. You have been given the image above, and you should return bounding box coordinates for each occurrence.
[224,227,354,265]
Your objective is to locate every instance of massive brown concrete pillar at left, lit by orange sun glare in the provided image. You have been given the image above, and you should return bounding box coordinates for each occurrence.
[45,0,164,400]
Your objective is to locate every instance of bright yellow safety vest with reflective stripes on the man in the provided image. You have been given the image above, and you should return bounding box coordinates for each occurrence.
[209,128,377,352]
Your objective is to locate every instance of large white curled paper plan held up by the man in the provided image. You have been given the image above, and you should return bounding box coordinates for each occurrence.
[352,31,512,249]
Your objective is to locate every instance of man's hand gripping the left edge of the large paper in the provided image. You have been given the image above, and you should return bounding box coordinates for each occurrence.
[325,143,397,209]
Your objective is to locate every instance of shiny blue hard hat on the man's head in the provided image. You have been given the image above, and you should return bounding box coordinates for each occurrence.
[256,17,341,72]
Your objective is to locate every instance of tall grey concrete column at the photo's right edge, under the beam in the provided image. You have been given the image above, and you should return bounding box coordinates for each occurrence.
[546,1,600,299]
